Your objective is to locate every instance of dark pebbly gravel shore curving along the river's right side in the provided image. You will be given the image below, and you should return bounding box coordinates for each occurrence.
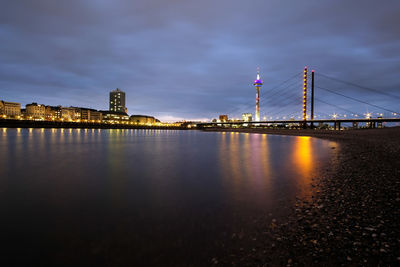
[206,128,400,266]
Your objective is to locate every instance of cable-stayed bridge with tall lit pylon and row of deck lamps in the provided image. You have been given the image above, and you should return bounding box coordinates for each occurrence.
[198,67,400,129]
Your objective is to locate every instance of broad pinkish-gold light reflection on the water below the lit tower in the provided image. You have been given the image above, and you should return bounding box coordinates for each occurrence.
[218,132,272,208]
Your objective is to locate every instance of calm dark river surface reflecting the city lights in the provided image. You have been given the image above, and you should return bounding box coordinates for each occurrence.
[0,128,337,266]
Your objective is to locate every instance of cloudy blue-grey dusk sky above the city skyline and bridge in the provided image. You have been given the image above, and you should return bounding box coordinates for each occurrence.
[0,0,400,121]
